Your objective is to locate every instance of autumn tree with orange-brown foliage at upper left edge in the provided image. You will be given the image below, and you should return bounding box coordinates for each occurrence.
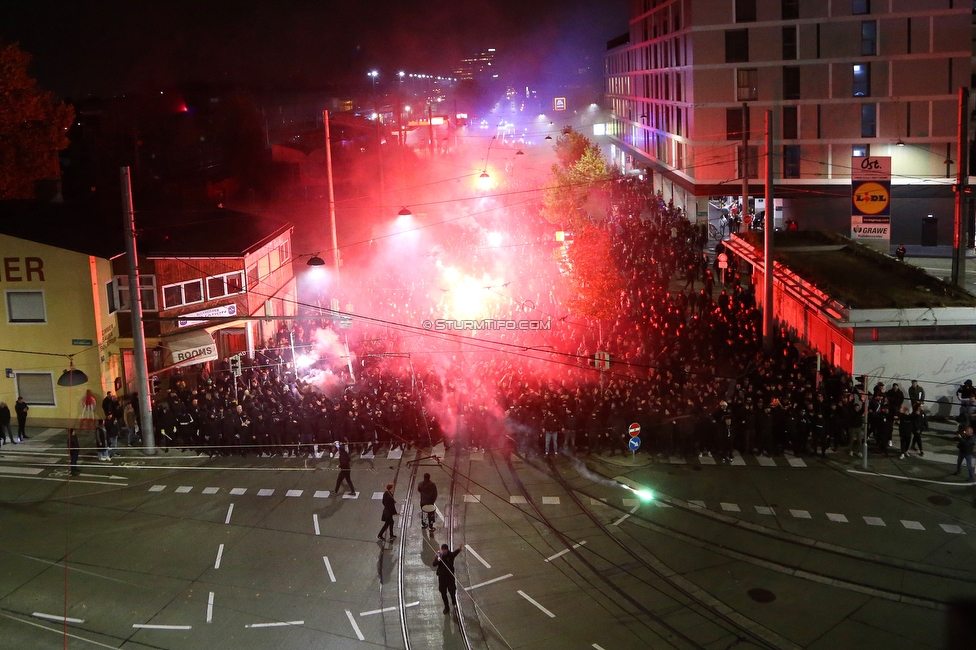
[0,42,75,199]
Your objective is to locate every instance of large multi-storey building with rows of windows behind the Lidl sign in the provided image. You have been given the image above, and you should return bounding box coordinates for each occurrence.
[605,0,973,244]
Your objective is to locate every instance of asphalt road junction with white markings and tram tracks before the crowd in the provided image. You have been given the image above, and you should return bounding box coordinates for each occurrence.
[0,426,976,650]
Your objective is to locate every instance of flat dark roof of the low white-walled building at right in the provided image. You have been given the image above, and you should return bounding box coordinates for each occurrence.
[744,230,976,309]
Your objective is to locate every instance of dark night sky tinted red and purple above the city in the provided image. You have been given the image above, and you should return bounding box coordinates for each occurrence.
[0,0,627,98]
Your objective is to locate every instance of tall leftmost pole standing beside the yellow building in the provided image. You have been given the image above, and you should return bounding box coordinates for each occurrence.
[119,167,156,456]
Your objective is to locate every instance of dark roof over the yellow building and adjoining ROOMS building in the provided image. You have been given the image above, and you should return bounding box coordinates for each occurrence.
[0,201,291,259]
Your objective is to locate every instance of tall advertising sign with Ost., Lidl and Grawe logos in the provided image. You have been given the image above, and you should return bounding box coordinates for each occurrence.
[851,156,891,253]
